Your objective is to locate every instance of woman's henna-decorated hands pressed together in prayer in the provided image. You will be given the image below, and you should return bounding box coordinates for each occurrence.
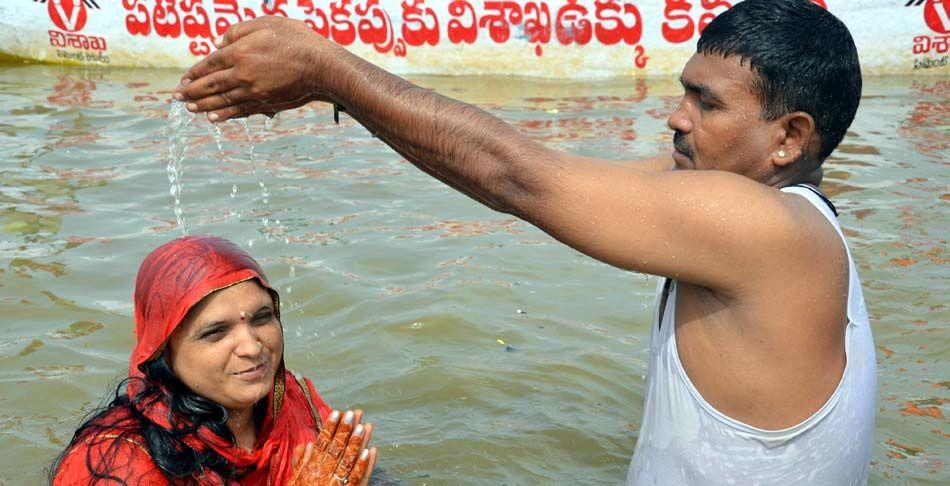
[288,410,376,486]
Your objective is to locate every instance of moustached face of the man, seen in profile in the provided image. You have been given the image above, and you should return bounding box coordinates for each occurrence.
[667,53,782,182]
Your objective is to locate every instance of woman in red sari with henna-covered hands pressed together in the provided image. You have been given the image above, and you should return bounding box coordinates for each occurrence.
[51,236,376,485]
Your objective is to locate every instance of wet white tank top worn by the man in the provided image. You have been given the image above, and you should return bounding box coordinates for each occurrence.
[627,187,877,486]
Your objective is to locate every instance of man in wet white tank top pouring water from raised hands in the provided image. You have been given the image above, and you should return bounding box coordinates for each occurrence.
[175,0,876,484]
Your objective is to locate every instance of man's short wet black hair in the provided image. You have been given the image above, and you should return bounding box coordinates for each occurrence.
[696,0,861,160]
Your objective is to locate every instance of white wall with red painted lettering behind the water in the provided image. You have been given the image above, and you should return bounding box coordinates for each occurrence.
[0,0,950,78]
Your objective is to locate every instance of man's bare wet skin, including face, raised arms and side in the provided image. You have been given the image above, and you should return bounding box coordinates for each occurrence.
[175,18,848,429]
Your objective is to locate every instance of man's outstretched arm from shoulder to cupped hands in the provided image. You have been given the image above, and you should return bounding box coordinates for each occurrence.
[179,18,832,294]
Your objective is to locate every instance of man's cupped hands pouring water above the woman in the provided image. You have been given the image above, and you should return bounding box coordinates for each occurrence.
[174,17,350,122]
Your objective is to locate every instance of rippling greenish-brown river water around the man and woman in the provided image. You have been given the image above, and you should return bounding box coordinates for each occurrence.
[0,65,950,485]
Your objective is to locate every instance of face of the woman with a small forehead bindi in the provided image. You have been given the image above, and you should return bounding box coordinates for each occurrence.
[168,280,284,410]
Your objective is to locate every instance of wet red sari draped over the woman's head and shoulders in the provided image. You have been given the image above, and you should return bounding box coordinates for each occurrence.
[53,236,330,486]
